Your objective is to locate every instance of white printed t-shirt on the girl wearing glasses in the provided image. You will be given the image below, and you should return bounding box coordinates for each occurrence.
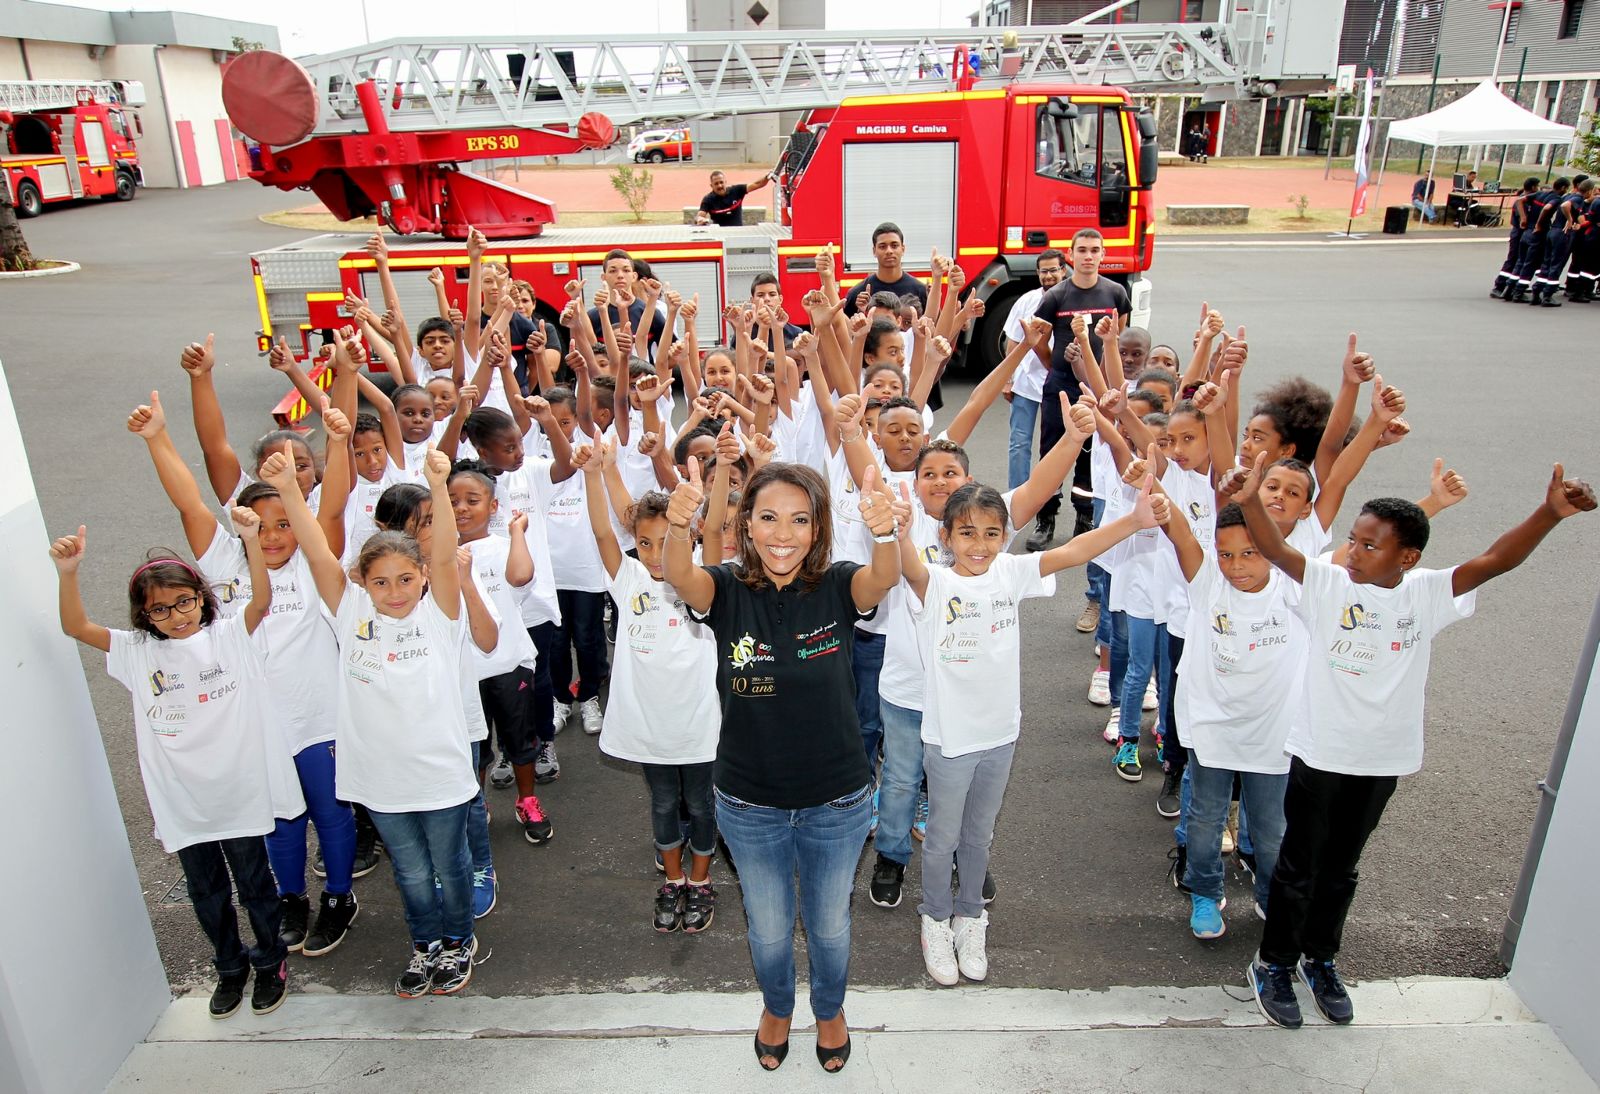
[106,616,306,851]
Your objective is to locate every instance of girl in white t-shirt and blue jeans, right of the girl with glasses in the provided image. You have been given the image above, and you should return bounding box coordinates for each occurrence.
[261,449,478,998]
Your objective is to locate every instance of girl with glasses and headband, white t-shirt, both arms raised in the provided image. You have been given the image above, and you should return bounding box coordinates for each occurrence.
[50,518,306,1019]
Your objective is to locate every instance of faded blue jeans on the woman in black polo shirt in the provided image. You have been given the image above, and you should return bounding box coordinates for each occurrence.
[715,782,876,1022]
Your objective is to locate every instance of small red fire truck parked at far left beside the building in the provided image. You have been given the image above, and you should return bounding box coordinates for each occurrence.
[0,80,144,216]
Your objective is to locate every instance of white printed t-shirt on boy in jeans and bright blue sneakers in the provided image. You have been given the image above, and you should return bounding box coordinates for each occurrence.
[1176,552,1309,774]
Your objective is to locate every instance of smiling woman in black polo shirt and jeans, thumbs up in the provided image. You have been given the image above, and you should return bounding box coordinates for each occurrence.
[666,459,899,1072]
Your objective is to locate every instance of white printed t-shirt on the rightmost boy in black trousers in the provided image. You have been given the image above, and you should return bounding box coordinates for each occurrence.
[1286,558,1477,776]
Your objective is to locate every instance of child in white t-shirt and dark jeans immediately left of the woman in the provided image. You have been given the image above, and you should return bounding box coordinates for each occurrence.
[573,438,722,934]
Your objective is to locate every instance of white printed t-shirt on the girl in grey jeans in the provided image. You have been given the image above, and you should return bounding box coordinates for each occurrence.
[910,555,1056,757]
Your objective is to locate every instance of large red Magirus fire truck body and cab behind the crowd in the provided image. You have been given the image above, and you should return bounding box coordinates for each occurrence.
[251,85,1157,421]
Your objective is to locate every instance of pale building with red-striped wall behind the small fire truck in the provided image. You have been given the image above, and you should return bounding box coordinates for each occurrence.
[0,0,278,187]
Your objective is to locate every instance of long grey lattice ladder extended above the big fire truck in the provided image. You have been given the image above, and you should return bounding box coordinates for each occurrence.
[288,14,1328,134]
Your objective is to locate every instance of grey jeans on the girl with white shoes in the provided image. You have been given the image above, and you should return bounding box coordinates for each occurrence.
[917,742,1016,921]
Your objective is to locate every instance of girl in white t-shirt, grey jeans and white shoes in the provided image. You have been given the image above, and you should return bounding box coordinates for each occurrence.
[901,480,1157,985]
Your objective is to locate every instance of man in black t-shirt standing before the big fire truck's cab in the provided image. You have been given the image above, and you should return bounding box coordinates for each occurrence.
[1027,229,1133,550]
